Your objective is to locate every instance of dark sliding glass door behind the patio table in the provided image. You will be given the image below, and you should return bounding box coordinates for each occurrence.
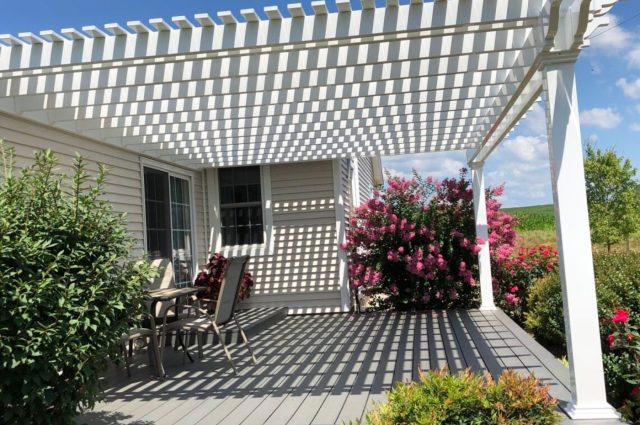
[144,167,193,286]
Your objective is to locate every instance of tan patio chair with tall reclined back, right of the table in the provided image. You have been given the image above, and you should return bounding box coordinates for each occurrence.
[160,255,257,373]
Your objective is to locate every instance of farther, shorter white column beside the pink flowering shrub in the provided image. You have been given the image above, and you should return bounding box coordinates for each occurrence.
[469,157,496,310]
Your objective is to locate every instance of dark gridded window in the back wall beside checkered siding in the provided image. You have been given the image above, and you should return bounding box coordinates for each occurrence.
[218,166,264,246]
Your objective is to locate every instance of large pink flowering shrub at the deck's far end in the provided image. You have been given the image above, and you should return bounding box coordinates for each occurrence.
[342,169,516,310]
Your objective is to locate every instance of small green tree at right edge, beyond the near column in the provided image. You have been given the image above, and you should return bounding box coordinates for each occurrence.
[584,145,640,251]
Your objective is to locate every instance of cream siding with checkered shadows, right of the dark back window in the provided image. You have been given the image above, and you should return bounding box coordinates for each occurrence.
[239,161,340,312]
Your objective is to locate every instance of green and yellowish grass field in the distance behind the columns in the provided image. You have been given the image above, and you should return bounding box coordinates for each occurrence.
[502,205,640,252]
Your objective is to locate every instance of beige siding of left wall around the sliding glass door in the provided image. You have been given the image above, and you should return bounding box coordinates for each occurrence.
[0,112,206,264]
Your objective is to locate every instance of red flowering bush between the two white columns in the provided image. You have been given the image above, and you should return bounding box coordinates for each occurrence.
[489,243,558,323]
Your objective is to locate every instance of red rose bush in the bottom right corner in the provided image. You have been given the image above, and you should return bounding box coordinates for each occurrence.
[603,309,640,423]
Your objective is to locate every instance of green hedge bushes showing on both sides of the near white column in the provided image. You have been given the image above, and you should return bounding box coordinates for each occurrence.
[525,253,640,419]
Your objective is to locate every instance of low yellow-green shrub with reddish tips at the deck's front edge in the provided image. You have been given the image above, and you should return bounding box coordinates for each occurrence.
[356,370,560,425]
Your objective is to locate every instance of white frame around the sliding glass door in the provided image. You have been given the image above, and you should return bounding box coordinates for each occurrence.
[140,157,200,282]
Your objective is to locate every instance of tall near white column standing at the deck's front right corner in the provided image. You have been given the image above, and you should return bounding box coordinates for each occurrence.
[542,57,618,419]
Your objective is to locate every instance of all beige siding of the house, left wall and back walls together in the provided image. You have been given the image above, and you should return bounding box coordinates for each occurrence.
[0,113,380,313]
